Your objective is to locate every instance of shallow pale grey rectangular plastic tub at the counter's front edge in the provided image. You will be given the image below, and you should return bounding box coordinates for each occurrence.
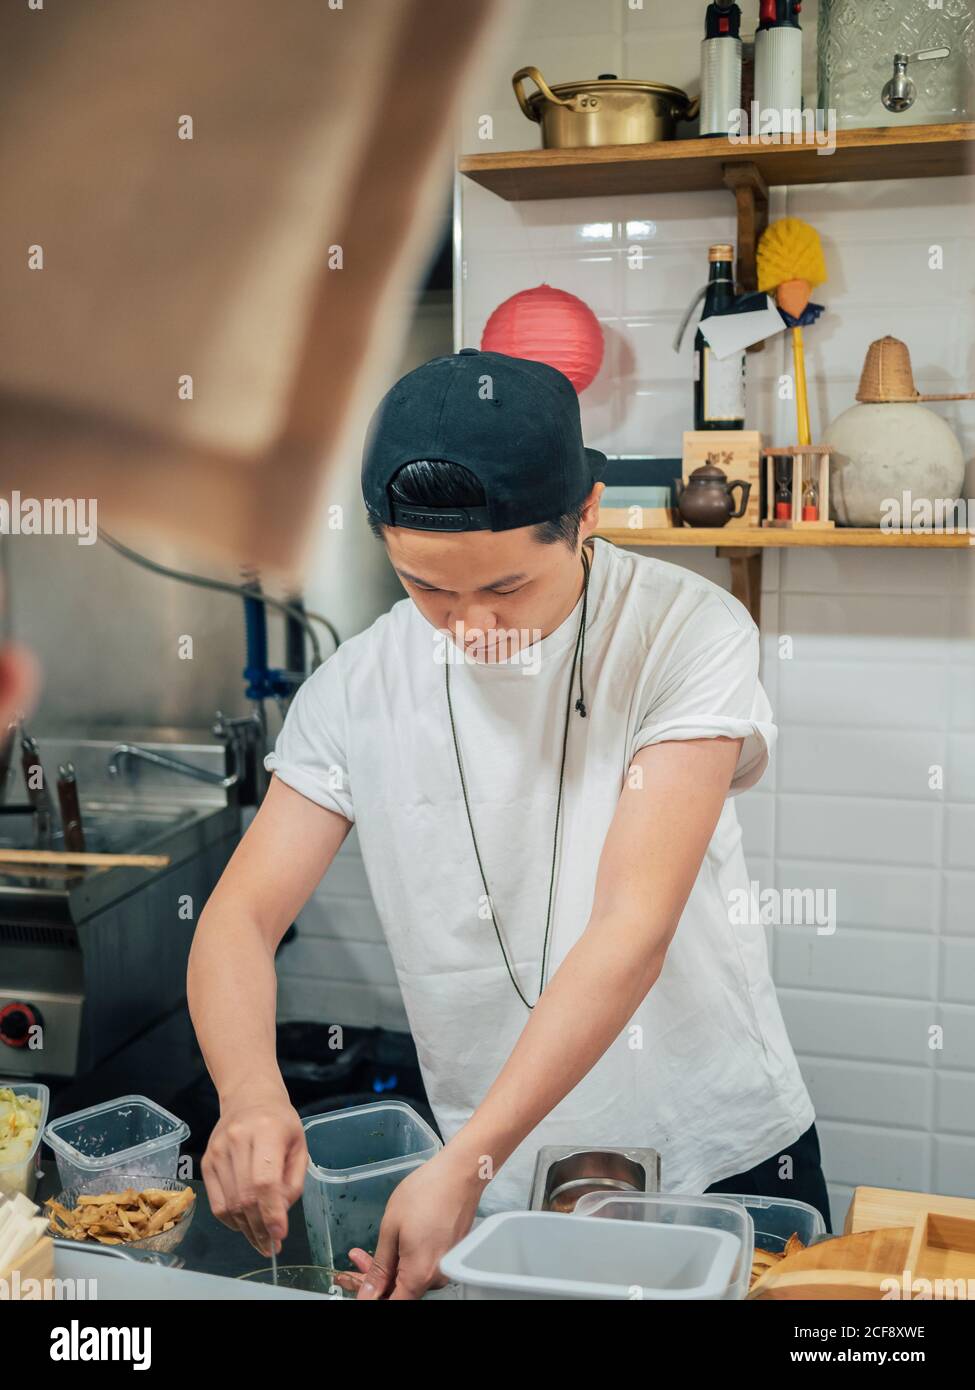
[440,1212,741,1301]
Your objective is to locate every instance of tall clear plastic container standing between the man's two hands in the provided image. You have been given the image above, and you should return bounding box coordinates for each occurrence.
[302,1101,444,1269]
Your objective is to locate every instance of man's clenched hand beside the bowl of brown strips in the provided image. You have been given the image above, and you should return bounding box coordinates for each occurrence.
[200,1088,307,1255]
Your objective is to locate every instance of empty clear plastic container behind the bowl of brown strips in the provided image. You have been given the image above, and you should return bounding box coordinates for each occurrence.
[45,1095,189,1193]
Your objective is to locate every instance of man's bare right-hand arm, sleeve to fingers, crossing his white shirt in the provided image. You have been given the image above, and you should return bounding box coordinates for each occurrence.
[360,738,741,1298]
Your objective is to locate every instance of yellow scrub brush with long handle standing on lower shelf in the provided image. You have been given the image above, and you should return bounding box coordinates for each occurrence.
[758,217,826,445]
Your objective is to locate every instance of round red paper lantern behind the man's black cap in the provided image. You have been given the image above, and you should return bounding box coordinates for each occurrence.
[481,285,604,391]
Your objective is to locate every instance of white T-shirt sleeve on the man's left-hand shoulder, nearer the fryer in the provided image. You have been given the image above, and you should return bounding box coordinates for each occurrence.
[264,649,356,821]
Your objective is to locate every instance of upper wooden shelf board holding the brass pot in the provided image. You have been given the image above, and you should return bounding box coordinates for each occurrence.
[458,121,975,203]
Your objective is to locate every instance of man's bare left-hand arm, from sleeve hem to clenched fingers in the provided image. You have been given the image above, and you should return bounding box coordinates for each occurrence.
[186,777,352,1251]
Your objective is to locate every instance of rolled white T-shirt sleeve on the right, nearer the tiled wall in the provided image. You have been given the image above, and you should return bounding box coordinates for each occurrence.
[630,626,777,796]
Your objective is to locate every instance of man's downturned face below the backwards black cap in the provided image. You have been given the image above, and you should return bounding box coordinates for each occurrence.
[384,484,602,662]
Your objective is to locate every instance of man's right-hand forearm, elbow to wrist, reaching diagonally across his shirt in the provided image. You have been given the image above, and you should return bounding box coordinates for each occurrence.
[448,917,670,1177]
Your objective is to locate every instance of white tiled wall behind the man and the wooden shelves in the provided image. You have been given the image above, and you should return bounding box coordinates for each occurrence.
[278,0,975,1222]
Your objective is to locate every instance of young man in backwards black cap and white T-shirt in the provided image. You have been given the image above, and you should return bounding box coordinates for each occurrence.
[189,349,829,1298]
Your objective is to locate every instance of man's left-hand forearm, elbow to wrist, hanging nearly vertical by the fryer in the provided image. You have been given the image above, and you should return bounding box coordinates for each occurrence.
[186,906,284,1104]
